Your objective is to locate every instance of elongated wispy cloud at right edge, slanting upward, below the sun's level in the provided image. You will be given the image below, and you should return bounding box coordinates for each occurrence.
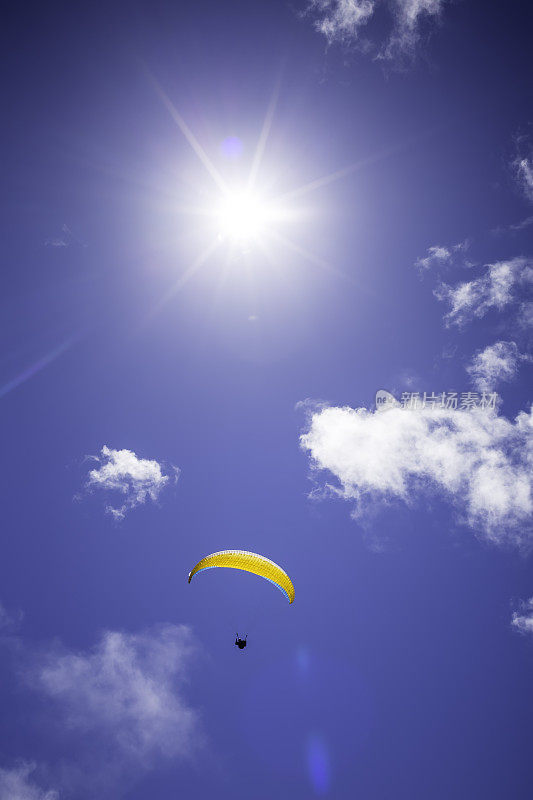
[434,258,533,327]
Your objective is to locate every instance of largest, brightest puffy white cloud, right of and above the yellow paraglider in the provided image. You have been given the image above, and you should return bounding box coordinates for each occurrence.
[301,407,533,544]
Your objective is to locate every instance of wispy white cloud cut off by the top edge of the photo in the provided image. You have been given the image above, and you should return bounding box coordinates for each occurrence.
[304,0,446,62]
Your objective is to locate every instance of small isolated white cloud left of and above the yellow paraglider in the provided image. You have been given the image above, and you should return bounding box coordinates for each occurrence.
[85,445,179,519]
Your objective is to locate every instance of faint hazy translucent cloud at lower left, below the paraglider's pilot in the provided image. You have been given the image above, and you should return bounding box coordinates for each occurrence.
[30,625,202,769]
